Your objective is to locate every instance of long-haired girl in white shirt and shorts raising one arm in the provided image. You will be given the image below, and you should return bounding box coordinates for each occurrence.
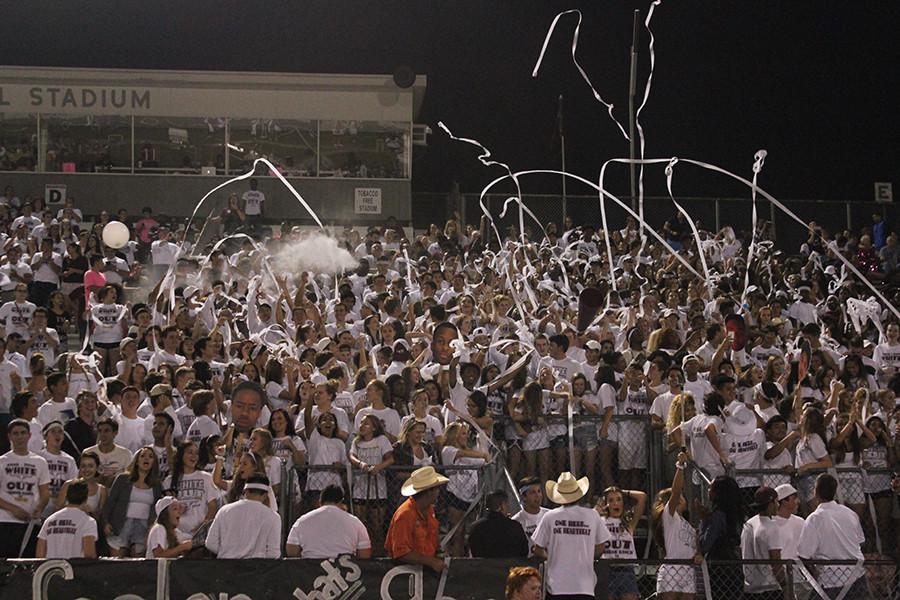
[650,452,698,600]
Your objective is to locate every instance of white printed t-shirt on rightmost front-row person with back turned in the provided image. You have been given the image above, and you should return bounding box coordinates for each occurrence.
[797,501,866,588]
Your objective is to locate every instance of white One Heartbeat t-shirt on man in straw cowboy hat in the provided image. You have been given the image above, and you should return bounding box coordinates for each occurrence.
[532,504,612,597]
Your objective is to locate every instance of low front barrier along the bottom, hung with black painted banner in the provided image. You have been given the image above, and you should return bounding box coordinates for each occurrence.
[0,556,900,600]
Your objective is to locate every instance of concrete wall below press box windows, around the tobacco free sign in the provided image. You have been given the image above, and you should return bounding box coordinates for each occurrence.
[0,172,412,223]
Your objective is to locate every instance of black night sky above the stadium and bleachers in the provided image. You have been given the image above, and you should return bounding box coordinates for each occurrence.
[0,0,900,200]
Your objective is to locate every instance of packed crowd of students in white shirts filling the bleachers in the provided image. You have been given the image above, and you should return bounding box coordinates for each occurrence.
[0,182,900,596]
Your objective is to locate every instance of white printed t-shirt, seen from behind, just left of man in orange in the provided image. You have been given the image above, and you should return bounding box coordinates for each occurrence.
[287,504,372,559]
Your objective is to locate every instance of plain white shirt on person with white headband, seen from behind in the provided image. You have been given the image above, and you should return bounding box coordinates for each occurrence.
[206,499,281,558]
